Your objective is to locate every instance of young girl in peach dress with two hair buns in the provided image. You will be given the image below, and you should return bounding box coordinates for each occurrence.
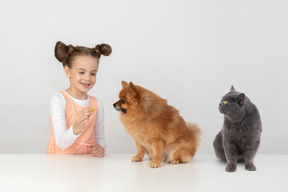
[47,41,112,157]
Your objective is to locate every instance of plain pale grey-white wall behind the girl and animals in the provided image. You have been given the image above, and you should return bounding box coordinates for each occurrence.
[0,0,288,154]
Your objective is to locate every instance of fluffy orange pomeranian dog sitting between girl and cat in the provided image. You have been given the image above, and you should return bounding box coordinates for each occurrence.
[113,81,201,168]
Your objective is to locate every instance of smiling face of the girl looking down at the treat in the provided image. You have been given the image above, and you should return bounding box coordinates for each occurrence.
[64,56,98,99]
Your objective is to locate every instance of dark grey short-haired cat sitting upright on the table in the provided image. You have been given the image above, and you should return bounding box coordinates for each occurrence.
[213,86,262,172]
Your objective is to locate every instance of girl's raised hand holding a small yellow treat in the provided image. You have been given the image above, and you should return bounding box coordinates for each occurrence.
[73,109,93,135]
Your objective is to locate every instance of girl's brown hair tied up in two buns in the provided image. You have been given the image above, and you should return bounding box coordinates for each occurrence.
[54,41,112,68]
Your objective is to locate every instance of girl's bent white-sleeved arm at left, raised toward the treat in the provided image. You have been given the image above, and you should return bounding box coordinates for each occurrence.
[50,93,81,149]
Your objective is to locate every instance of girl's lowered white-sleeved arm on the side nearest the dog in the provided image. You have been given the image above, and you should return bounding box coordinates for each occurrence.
[95,99,106,151]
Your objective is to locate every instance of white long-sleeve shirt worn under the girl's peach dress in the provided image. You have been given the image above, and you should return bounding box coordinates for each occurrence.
[50,92,106,151]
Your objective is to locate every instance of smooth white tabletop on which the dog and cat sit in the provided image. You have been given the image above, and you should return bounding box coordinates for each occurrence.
[0,154,288,192]
